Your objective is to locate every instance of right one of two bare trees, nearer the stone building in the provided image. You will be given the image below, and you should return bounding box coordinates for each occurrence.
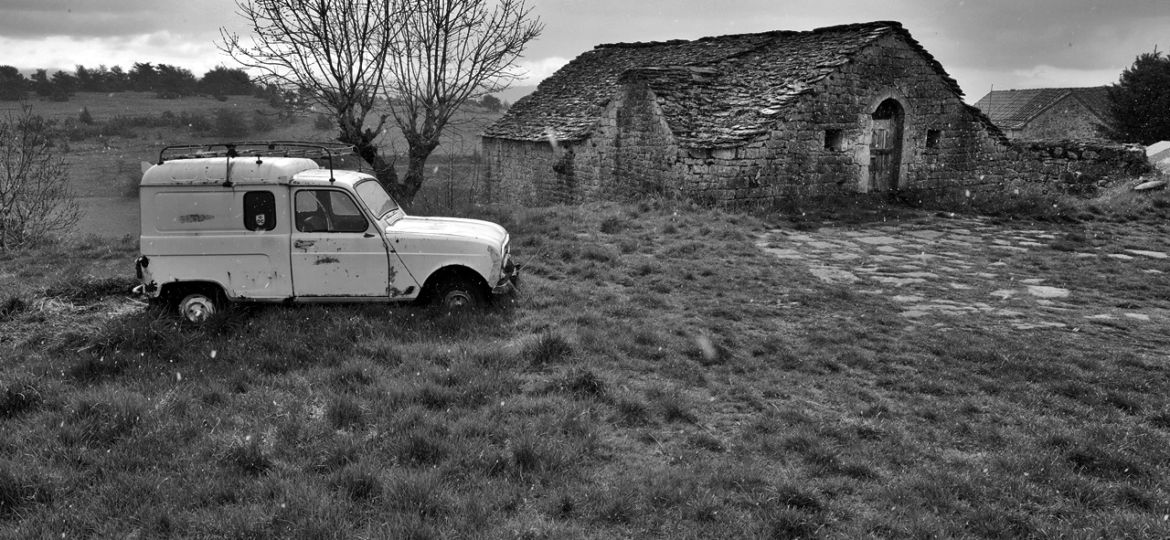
[385,0,543,202]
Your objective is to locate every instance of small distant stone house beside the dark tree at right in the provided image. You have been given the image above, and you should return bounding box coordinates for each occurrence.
[975,86,1109,140]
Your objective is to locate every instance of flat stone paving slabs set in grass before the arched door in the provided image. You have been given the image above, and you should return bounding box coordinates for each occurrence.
[756,217,1170,331]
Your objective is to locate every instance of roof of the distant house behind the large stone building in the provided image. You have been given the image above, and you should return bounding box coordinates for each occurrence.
[975,86,1109,130]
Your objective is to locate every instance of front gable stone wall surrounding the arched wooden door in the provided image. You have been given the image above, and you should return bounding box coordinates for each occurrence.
[676,36,1006,203]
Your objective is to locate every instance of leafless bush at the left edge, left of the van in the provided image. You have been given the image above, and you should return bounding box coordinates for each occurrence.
[0,106,81,251]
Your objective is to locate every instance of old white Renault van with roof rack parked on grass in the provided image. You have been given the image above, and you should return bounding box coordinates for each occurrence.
[135,143,518,323]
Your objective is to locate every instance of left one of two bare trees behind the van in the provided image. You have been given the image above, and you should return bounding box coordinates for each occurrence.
[219,0,400,193]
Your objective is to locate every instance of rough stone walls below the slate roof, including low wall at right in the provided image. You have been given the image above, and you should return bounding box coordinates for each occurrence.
[484,35,1130,205]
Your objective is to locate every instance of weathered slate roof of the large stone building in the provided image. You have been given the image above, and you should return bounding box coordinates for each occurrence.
[484,21,963,146]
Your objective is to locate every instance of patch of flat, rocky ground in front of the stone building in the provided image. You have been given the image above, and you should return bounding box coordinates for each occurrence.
[757,212,1170,333]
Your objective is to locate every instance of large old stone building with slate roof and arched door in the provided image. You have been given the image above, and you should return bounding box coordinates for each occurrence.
[483,21,1007,203]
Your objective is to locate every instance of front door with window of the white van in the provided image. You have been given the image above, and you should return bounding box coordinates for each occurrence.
[291,188,390,298]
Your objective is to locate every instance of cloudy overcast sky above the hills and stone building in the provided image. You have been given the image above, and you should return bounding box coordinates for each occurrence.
[0,0,1170,102]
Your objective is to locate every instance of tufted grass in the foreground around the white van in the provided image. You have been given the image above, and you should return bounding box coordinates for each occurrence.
[0,177,1170,539]
